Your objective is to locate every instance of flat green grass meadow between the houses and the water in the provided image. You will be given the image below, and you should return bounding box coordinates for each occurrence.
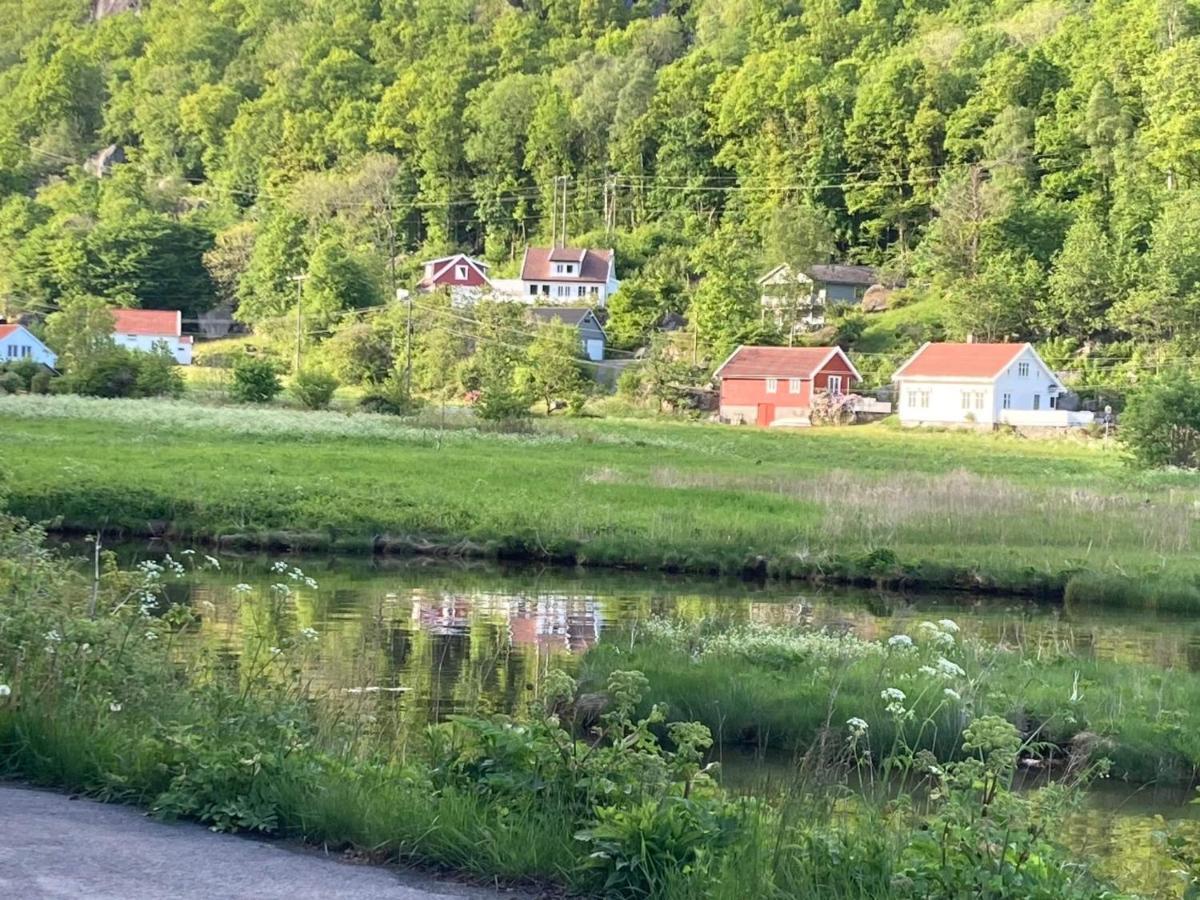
[0,396,1200,606]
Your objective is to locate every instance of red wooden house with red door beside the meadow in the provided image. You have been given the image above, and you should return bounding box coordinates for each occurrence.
[714,347,862,427]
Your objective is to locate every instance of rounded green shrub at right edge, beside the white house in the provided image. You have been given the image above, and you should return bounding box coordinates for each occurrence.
[1120,372,1200,468]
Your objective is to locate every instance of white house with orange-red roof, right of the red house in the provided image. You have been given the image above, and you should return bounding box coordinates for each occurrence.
[892,343,1092,427]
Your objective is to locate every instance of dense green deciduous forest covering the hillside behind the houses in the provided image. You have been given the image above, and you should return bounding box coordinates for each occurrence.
[0,0,1200,377]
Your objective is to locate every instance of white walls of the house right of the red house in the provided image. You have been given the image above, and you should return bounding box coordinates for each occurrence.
[896,348,1062,427]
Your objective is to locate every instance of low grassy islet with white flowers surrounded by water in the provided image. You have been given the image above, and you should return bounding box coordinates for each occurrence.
[581,619,1200,784]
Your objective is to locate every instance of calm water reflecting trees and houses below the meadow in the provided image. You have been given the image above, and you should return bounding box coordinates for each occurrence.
[84,545,1200,896]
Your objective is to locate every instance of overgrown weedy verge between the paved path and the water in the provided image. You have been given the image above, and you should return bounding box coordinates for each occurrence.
[0,516,1111,900]
